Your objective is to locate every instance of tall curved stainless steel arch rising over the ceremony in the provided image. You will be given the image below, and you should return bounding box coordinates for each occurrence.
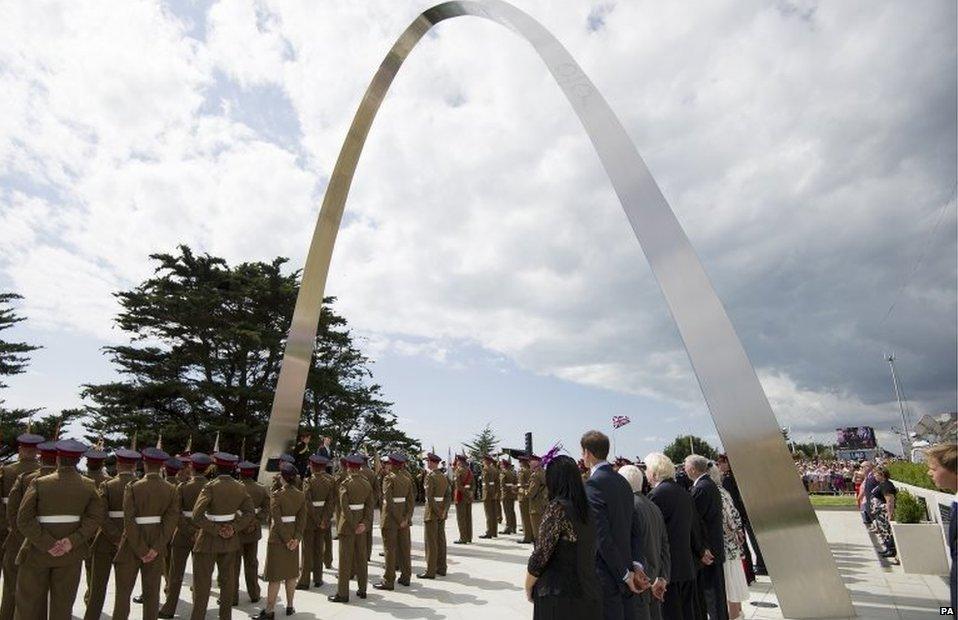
[261,0,854,618]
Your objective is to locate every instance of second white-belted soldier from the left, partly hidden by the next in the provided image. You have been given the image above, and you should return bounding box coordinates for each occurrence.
[83,448,140,620]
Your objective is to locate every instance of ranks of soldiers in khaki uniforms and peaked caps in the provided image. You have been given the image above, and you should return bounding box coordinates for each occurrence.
[0,432,547,620]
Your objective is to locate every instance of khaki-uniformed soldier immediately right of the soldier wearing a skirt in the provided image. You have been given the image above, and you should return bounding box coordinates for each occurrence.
[296,454,337,590]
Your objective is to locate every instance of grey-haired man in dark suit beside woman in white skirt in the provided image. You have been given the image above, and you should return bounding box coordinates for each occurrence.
[685,454,728,620]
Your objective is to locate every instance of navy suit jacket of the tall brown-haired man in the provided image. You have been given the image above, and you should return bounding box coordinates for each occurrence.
[585,464,645,592]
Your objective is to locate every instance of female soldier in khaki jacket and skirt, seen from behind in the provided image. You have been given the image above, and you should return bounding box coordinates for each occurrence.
[254,462,306,620]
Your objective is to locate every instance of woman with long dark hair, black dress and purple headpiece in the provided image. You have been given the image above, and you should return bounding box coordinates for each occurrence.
[526,455,602,620]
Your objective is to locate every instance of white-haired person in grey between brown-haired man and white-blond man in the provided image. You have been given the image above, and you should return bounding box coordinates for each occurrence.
[619,464,672,620]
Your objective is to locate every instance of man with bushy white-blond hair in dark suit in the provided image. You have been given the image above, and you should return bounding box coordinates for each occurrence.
[645,452,704,620]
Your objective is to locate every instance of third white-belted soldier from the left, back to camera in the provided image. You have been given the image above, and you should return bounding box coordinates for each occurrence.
[113,448,180,620]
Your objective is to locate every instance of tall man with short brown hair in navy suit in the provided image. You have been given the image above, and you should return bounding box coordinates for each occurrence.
[580,431,649,620]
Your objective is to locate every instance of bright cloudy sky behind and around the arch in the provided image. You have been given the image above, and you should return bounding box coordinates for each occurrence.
[0,0,958,455]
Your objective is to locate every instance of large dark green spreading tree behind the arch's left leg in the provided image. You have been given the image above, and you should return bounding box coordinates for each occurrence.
[82,245,416,458]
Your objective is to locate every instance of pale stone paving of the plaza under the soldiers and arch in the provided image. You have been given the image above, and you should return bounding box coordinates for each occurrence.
[74,503,948,620]
